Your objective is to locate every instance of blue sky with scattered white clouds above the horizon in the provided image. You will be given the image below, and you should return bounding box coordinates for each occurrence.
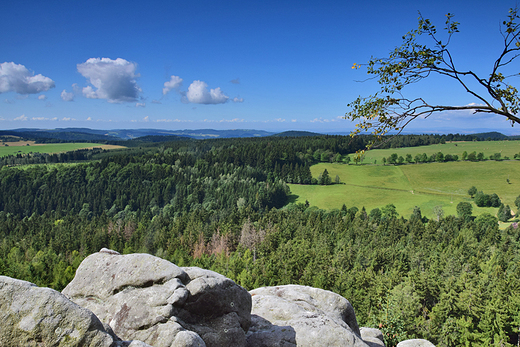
[0,0,520,134]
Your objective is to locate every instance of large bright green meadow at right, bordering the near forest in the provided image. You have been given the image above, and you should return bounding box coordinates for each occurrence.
[290,160,520,222]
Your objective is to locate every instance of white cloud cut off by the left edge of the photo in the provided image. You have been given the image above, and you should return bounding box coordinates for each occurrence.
[0,62,54,94]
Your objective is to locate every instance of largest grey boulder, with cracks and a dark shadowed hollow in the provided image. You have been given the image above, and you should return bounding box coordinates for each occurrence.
[63,249,251,347]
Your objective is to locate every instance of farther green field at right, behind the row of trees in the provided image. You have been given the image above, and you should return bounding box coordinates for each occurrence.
[350,141,520,164]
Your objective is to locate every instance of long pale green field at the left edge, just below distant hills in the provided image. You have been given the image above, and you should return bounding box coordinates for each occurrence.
[0,141,125,157]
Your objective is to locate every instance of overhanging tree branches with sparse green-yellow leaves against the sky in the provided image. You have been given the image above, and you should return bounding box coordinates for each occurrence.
[345,8,520,152]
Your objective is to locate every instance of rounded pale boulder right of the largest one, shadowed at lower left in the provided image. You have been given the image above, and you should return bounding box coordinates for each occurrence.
[247,285,368,347]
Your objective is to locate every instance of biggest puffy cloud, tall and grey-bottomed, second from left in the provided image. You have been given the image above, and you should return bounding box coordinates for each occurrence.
[77,58,141,103]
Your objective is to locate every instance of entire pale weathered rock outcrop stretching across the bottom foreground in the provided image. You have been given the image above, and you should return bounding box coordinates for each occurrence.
[0,249,384,347]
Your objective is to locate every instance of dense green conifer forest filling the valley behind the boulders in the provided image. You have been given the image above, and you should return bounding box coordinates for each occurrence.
[0,135,520,346]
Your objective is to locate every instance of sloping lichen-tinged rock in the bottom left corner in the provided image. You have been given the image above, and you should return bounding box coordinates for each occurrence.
[0,276,116,347]
